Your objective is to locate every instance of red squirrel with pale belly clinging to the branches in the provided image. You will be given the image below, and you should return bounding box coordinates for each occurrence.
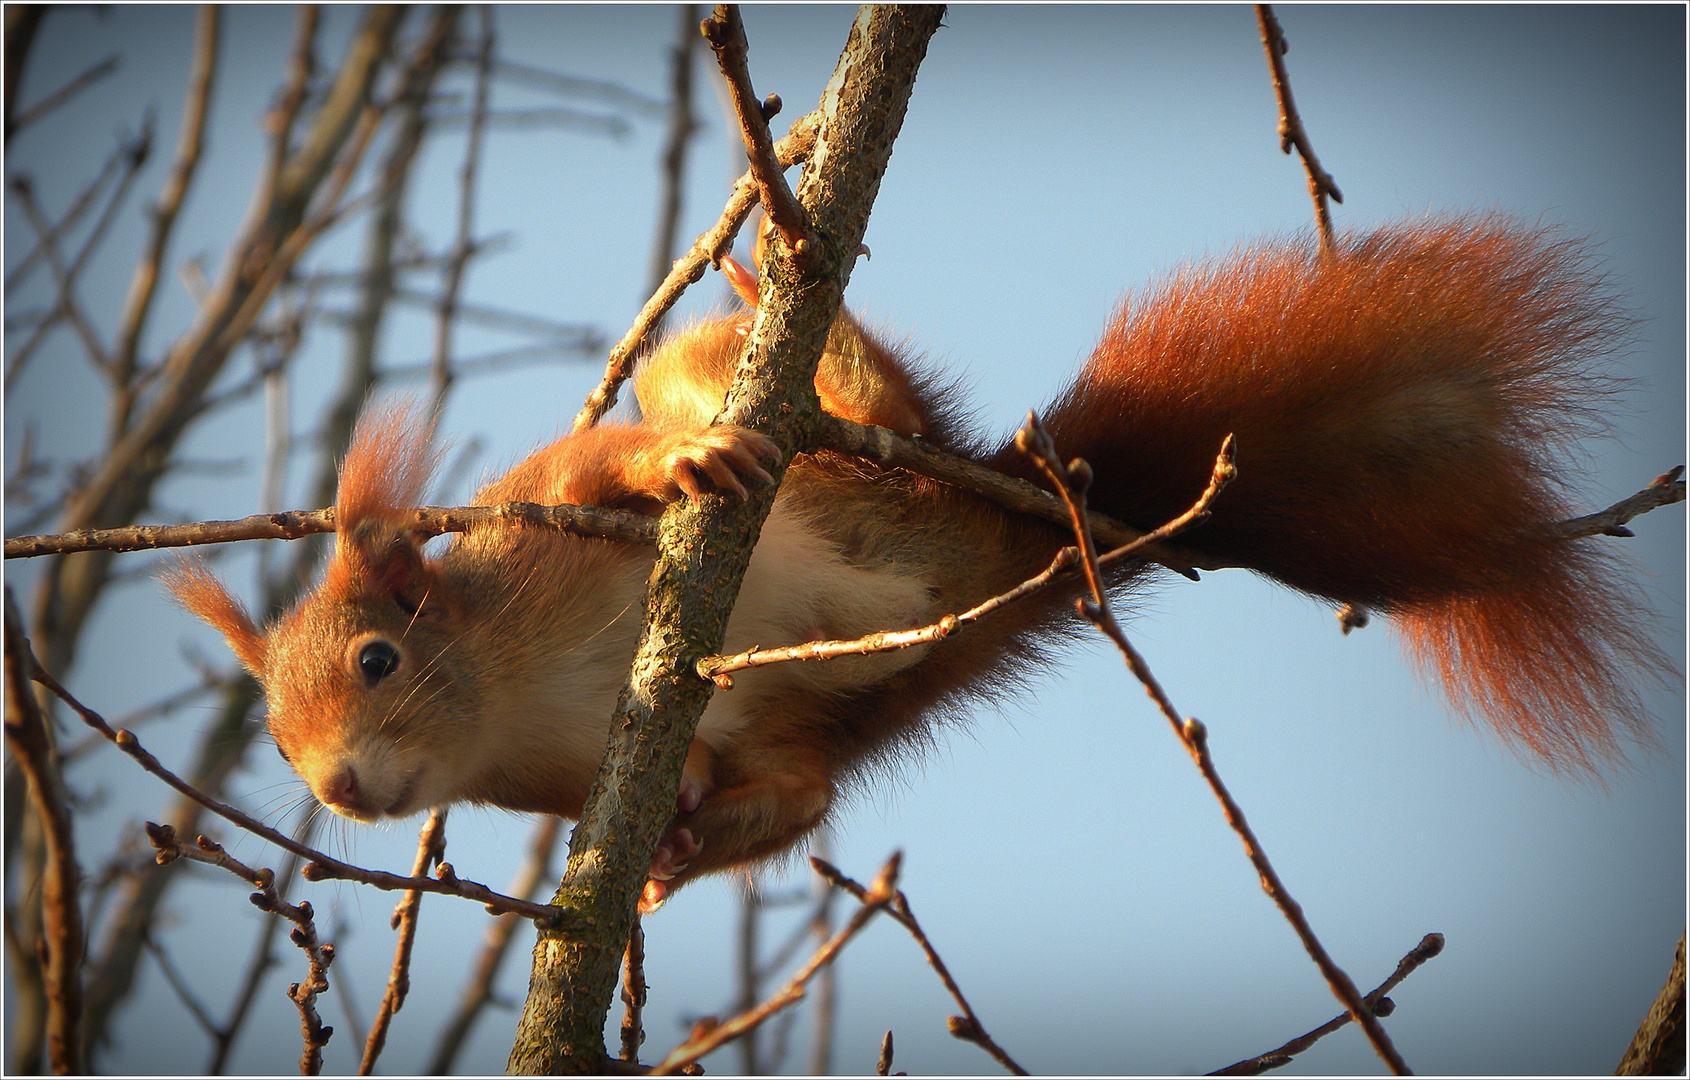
[171,216,1670,901]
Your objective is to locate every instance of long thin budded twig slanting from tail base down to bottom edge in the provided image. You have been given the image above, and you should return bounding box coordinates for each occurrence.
[1016,414,1409,1075]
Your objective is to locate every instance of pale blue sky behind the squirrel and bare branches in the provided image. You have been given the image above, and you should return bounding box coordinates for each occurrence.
[5,7,1685,1073]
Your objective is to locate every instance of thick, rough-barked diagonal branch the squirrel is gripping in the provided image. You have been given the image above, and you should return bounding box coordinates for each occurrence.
[509,5,943,1073]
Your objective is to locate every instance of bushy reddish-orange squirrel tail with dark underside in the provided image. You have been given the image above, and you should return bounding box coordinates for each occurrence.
[1006,216,1670,771]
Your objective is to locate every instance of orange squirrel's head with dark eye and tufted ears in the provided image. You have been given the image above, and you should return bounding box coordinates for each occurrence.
[166,407,477,821]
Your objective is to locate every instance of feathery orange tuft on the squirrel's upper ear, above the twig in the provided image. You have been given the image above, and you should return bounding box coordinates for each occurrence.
[335,401,438,539]
